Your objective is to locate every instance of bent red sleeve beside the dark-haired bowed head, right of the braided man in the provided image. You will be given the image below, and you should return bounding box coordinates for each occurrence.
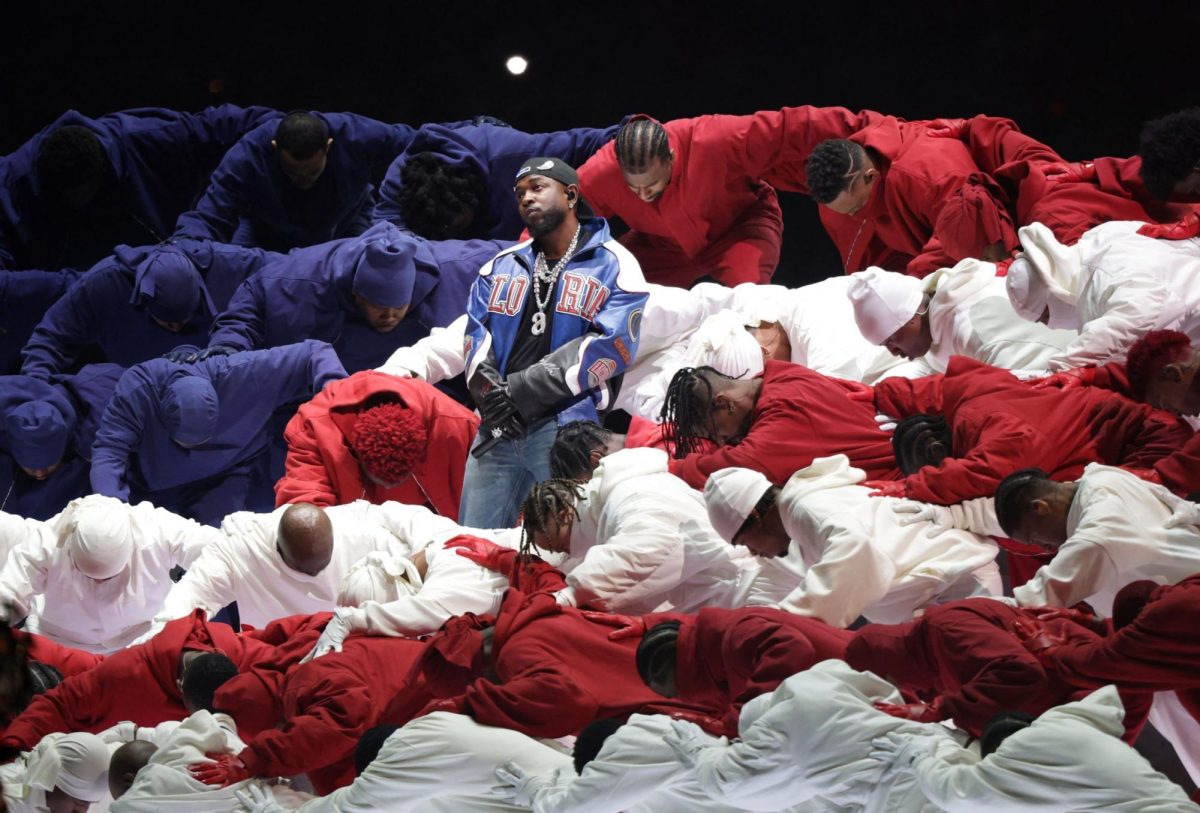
[902,414,1048,505]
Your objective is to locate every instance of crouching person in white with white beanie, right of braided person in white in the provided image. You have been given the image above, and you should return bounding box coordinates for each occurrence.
[704,454,1001,627]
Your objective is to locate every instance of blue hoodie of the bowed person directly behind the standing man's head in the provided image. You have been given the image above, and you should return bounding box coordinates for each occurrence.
[376,125,620,240]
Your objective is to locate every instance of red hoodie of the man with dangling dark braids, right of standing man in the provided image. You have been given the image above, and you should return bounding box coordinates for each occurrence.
[670,361,900,489]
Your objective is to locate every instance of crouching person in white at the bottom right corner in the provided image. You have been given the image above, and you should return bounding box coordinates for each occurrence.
[872,686,1200,813]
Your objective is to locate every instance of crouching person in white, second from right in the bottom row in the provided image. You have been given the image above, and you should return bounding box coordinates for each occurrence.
[667,661,962,813]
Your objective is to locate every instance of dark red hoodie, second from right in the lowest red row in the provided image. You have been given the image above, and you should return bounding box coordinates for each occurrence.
[846,598,1151,742]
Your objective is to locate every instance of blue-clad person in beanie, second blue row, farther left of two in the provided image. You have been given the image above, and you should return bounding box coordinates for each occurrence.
[22,239,282,378]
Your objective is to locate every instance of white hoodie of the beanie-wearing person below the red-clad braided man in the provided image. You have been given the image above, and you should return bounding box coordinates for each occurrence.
[778,454,1001,627]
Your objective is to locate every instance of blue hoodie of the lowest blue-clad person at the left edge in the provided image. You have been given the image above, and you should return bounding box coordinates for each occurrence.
[0,365,125,519]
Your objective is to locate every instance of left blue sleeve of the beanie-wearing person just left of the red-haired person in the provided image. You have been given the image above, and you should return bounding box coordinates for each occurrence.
[91,367,155,501]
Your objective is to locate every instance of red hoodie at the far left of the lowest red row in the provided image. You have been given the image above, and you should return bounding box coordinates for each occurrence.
[0,610,274,751]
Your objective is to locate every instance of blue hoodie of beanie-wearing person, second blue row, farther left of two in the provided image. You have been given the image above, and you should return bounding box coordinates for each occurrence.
[22,239,278,378]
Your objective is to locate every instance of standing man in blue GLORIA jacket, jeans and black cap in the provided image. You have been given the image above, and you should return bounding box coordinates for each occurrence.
[458,157,647,528]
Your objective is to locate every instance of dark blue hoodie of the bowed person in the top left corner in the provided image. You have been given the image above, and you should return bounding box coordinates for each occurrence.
[0,104,280,271]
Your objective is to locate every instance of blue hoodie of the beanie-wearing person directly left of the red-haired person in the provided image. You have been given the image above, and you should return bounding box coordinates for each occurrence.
[91,341,346,510]
